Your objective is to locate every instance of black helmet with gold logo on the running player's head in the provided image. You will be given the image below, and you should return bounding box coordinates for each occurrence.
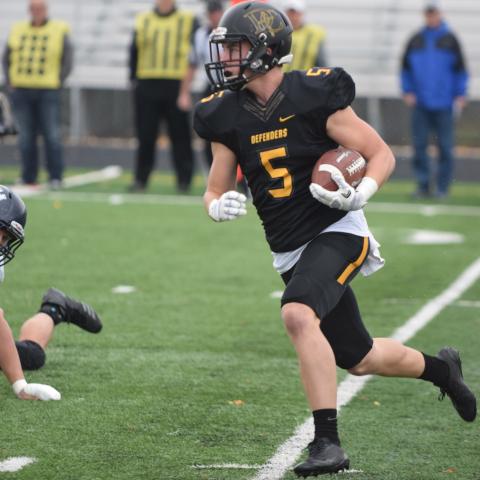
[205,2,293,91]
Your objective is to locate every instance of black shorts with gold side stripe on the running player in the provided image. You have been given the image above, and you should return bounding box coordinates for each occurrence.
[281,232,373,369]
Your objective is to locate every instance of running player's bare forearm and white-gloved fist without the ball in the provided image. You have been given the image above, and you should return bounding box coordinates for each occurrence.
[203,142,247,222]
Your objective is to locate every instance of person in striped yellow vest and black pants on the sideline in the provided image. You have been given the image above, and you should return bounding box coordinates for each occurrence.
[129,0,198,192]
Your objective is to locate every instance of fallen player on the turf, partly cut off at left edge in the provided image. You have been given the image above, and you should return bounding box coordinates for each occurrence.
[0,185,102,400]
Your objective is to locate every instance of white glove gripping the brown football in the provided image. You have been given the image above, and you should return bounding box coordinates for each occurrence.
[310,171,378,211]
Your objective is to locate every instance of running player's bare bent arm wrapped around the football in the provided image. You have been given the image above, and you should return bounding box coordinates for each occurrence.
[327,107,395,187]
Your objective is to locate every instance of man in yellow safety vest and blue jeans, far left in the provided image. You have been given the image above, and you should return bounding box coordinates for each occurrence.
[2,0,73,188]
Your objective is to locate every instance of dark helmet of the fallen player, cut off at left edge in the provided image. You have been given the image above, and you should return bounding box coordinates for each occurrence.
[0,185,27,266]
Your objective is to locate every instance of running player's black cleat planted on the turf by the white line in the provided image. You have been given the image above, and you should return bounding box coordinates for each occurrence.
[293,437,350,477]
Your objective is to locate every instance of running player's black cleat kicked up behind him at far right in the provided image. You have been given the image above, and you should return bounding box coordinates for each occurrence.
[437,347,477,422]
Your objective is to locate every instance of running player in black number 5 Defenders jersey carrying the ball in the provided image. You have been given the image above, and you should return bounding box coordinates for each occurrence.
[194,2,476,476]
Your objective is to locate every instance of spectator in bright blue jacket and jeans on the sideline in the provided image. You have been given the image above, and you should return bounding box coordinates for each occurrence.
[401,3,468,198]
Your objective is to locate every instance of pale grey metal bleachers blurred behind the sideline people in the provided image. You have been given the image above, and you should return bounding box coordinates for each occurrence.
[0,0,480,99]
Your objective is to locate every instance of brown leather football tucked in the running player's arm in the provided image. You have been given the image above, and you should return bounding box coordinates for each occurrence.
[312,147,367,192]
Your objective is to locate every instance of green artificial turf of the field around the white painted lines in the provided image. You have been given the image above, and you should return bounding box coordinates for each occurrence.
[0,176,480,480]
